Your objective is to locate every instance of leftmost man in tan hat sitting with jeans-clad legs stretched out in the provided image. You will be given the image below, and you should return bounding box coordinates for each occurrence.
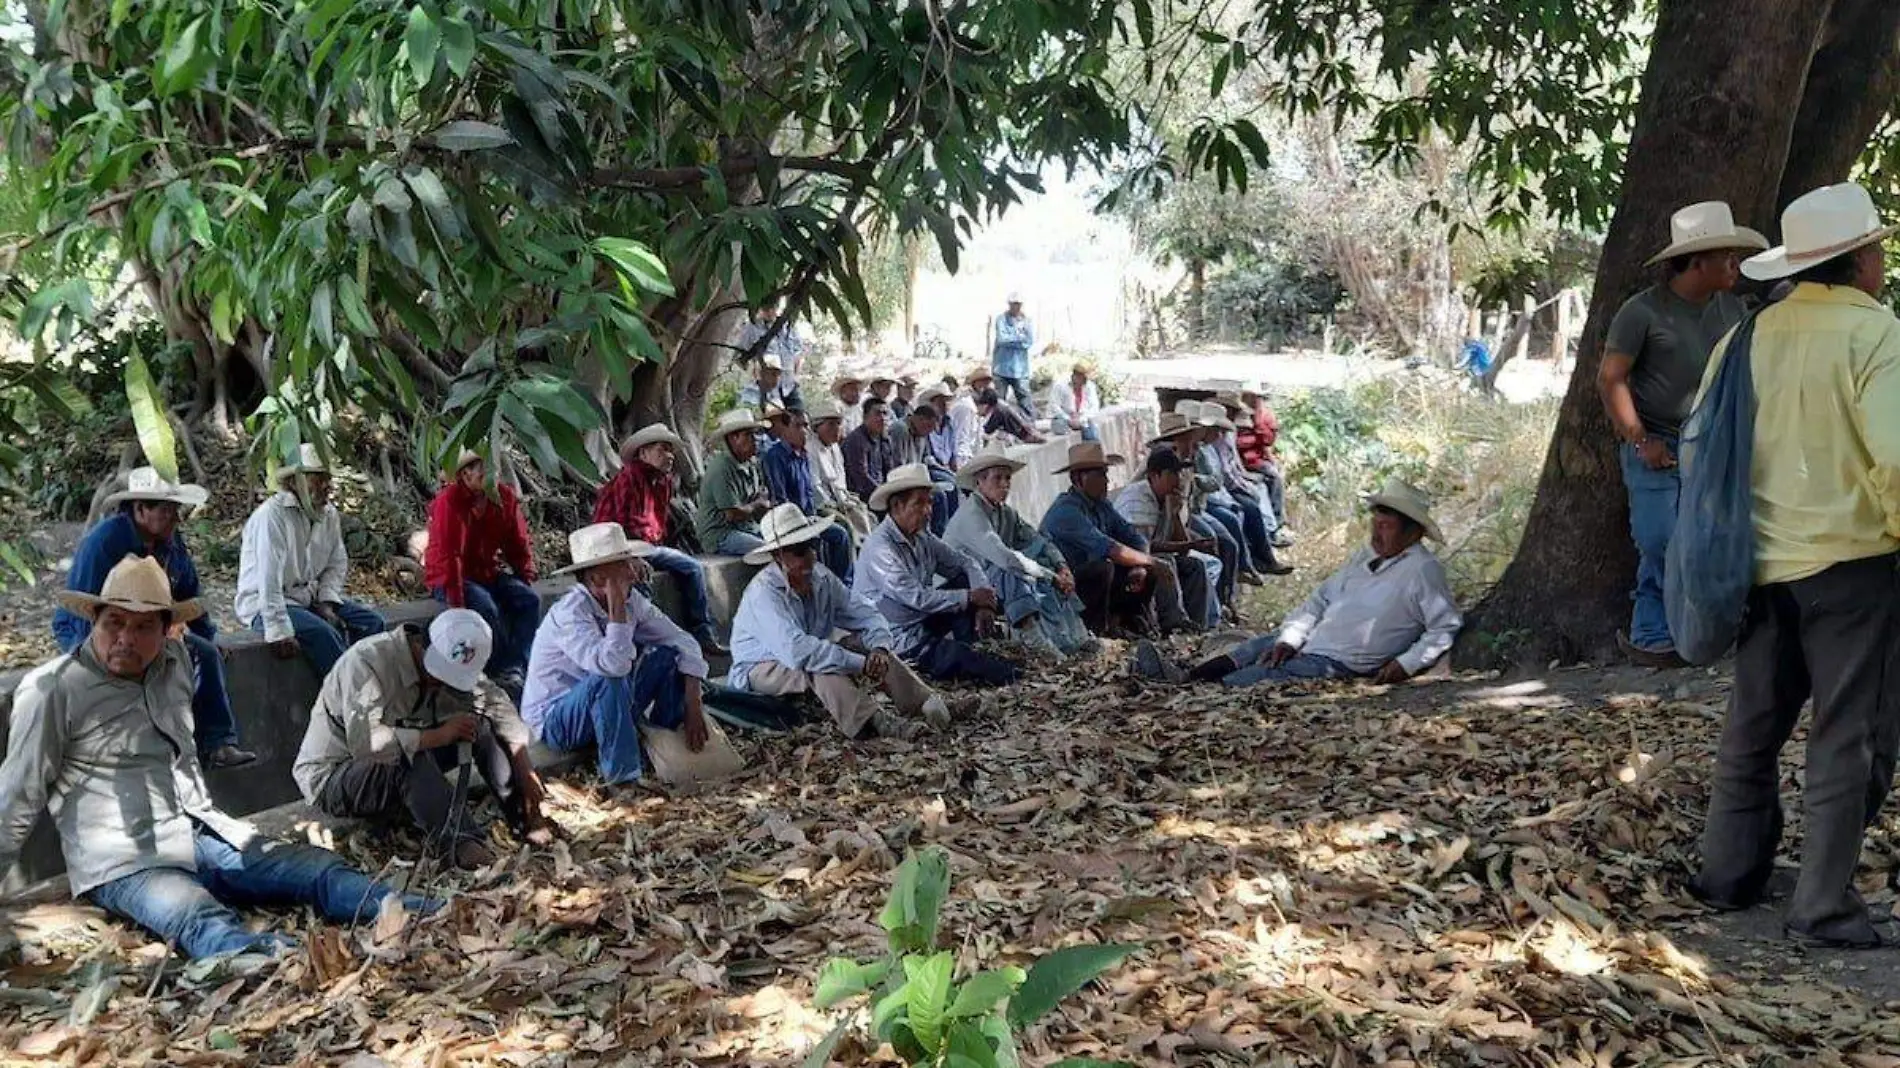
[0,557,441,958]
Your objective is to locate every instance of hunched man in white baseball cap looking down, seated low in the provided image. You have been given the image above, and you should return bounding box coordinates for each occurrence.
[291,608,553,868]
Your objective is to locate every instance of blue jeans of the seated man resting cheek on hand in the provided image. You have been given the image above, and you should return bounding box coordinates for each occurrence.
[534,646,686,783]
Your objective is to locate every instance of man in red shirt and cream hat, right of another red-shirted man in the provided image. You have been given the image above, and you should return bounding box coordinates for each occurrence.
[595,422,726,656]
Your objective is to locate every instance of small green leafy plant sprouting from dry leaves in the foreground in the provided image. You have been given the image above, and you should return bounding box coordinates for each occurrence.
[806,846,1138,1068]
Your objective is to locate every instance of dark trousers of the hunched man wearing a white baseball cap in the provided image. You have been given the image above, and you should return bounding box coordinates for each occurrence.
[317,718,521,848]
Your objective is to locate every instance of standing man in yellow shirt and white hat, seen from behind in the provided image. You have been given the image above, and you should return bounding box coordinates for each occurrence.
[1691,184,1900,948]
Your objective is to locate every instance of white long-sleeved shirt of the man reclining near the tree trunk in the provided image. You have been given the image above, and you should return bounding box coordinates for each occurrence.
[1281,545,1465,675]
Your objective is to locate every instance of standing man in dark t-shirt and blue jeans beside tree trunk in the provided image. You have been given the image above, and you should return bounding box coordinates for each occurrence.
[1596,201,1769,667]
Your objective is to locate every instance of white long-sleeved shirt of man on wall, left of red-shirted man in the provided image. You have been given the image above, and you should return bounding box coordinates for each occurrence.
[236,490,350,642]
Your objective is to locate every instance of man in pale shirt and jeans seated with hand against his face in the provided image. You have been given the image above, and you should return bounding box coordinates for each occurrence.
[521,520,749,787]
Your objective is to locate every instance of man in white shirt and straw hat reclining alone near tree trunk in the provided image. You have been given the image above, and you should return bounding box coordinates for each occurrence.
[1134,479,1465,686]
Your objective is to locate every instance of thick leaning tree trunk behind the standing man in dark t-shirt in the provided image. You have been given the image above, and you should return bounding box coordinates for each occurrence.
[1459,0,1839,663]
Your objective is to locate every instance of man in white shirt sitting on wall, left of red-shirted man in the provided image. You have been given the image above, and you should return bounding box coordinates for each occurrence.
[236,445,388,678]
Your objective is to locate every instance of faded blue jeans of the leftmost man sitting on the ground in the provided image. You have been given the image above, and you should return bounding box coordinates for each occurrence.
[87,827,443,958]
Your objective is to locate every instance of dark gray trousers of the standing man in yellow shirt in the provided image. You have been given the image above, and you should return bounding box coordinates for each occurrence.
[1695,555,1900,941]
